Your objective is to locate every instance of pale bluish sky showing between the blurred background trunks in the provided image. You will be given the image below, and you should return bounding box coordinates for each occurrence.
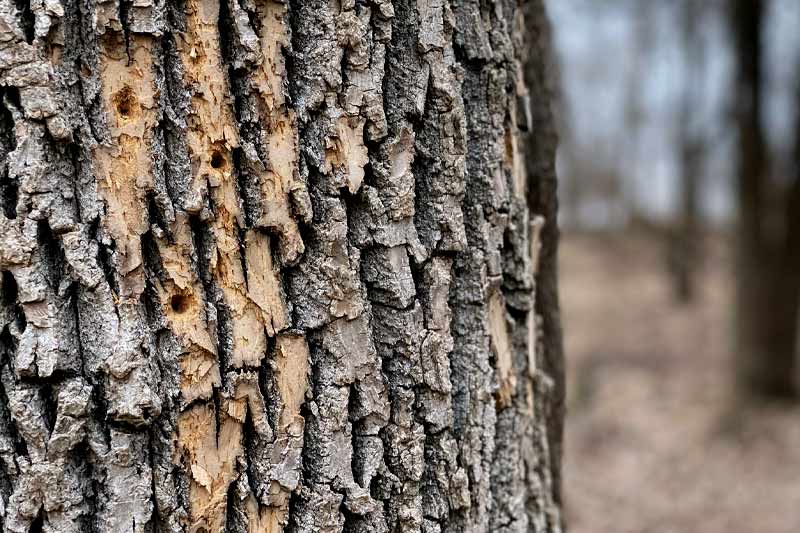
[547,0,800,224]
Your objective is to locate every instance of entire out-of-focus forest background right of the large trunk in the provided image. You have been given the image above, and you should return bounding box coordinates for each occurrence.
[548,0,800,533]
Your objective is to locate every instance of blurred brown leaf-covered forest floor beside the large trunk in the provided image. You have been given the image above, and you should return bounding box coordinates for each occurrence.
[560,233,800,533]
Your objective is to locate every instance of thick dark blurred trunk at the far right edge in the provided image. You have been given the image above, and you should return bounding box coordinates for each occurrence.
[730,0,798,396]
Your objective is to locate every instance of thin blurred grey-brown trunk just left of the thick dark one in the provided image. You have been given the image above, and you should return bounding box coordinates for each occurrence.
[669,0,705,303]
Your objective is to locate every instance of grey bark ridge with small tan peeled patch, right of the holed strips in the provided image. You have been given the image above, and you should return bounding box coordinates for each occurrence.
[289,1,390,532]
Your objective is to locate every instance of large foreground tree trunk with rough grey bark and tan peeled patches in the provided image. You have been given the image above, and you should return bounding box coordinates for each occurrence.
[0,0,563,533]
